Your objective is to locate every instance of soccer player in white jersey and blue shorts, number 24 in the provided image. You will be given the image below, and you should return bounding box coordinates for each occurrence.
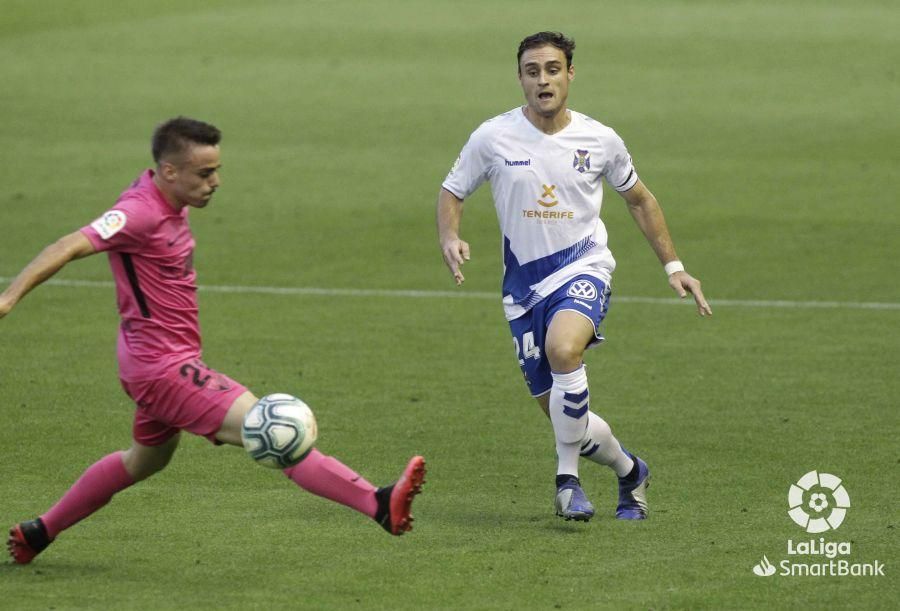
[437,32,712,521]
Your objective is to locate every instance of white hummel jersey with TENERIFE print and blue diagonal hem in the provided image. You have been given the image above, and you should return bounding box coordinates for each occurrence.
[443,107,638,320]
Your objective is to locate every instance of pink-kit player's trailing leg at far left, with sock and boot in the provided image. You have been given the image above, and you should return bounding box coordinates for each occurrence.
[7,434,178,564]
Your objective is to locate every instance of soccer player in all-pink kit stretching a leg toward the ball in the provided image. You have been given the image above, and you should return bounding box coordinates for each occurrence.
[0,117,425,564]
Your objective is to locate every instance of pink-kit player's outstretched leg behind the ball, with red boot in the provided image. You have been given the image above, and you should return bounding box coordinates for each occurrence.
[215,392,425,535]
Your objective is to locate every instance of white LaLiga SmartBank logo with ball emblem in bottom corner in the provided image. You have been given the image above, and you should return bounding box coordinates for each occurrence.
[753,471,884,577]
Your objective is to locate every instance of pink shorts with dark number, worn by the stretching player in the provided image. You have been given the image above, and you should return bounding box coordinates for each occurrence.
[122,359,247,446]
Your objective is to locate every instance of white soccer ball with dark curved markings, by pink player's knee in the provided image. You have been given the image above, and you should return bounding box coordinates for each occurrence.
[241,393,318,469]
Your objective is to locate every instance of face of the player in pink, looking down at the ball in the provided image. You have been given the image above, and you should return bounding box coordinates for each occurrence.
[161,144,222,208]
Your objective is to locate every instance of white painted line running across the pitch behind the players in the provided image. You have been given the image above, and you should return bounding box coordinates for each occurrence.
[0,276,900,310]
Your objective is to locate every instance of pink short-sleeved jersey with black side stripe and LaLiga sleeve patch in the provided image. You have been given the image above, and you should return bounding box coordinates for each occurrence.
[81,170,200,381]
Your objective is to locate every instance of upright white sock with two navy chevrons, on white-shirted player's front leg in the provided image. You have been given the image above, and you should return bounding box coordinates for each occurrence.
[550,365,590,477]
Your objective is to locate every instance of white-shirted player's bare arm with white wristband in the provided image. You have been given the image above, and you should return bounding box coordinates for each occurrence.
[620,180,712,316]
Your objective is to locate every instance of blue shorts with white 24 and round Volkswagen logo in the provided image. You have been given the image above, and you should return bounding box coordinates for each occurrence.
[509,275,611,397]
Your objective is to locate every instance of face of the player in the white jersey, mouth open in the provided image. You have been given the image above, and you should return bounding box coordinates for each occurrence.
[519,45,575,117]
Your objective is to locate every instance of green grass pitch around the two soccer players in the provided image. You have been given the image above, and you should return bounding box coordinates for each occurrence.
[0,0,900,609]
